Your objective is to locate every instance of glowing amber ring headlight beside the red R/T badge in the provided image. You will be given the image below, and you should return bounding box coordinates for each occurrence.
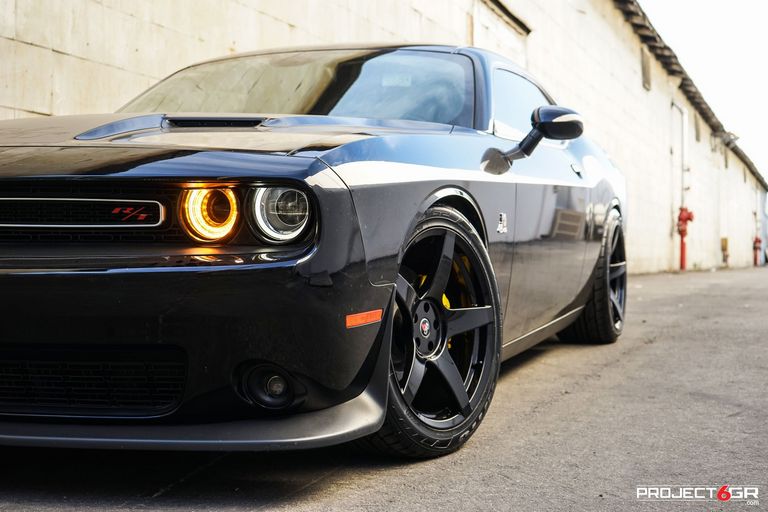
[182,188,238,242]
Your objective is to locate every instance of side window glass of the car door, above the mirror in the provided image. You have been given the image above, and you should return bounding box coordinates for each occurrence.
[493,69,549,140]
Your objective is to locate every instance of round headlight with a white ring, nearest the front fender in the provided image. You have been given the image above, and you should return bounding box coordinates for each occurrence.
[253,187,309,243]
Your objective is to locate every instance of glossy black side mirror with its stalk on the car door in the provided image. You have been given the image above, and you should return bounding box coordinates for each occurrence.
[504,105,584,162]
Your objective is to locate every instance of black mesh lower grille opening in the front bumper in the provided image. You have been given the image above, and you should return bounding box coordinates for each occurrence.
[0,345,187,417]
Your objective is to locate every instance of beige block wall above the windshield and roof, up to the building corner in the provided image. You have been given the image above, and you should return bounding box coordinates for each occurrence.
[0,0,525,119]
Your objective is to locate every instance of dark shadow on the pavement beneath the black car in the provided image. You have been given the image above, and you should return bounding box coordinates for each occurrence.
[0,339,576,511]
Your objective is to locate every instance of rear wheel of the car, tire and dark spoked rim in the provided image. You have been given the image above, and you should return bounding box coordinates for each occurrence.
[558,210,627,344]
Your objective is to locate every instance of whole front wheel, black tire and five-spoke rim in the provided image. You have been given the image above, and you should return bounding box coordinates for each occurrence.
[362,207,501,459]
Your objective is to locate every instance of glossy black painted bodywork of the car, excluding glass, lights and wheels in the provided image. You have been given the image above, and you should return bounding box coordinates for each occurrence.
[0,47,626,449]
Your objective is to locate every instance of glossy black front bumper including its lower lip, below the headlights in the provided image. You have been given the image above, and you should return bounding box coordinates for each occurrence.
[0,167,393,450]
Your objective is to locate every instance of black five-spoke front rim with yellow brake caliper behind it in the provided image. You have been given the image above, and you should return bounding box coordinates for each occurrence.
[392,228,496,429]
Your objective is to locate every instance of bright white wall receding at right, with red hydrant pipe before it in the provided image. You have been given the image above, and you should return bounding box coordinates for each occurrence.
[505,0,761,272]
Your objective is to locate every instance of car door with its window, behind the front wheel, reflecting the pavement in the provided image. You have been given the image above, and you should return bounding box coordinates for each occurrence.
[493,69,589,342]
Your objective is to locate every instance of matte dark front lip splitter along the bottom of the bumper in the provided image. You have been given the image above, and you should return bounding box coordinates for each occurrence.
[0,298,391,451]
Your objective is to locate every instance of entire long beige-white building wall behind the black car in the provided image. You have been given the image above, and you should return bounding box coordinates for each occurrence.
[0,0,760,272]
